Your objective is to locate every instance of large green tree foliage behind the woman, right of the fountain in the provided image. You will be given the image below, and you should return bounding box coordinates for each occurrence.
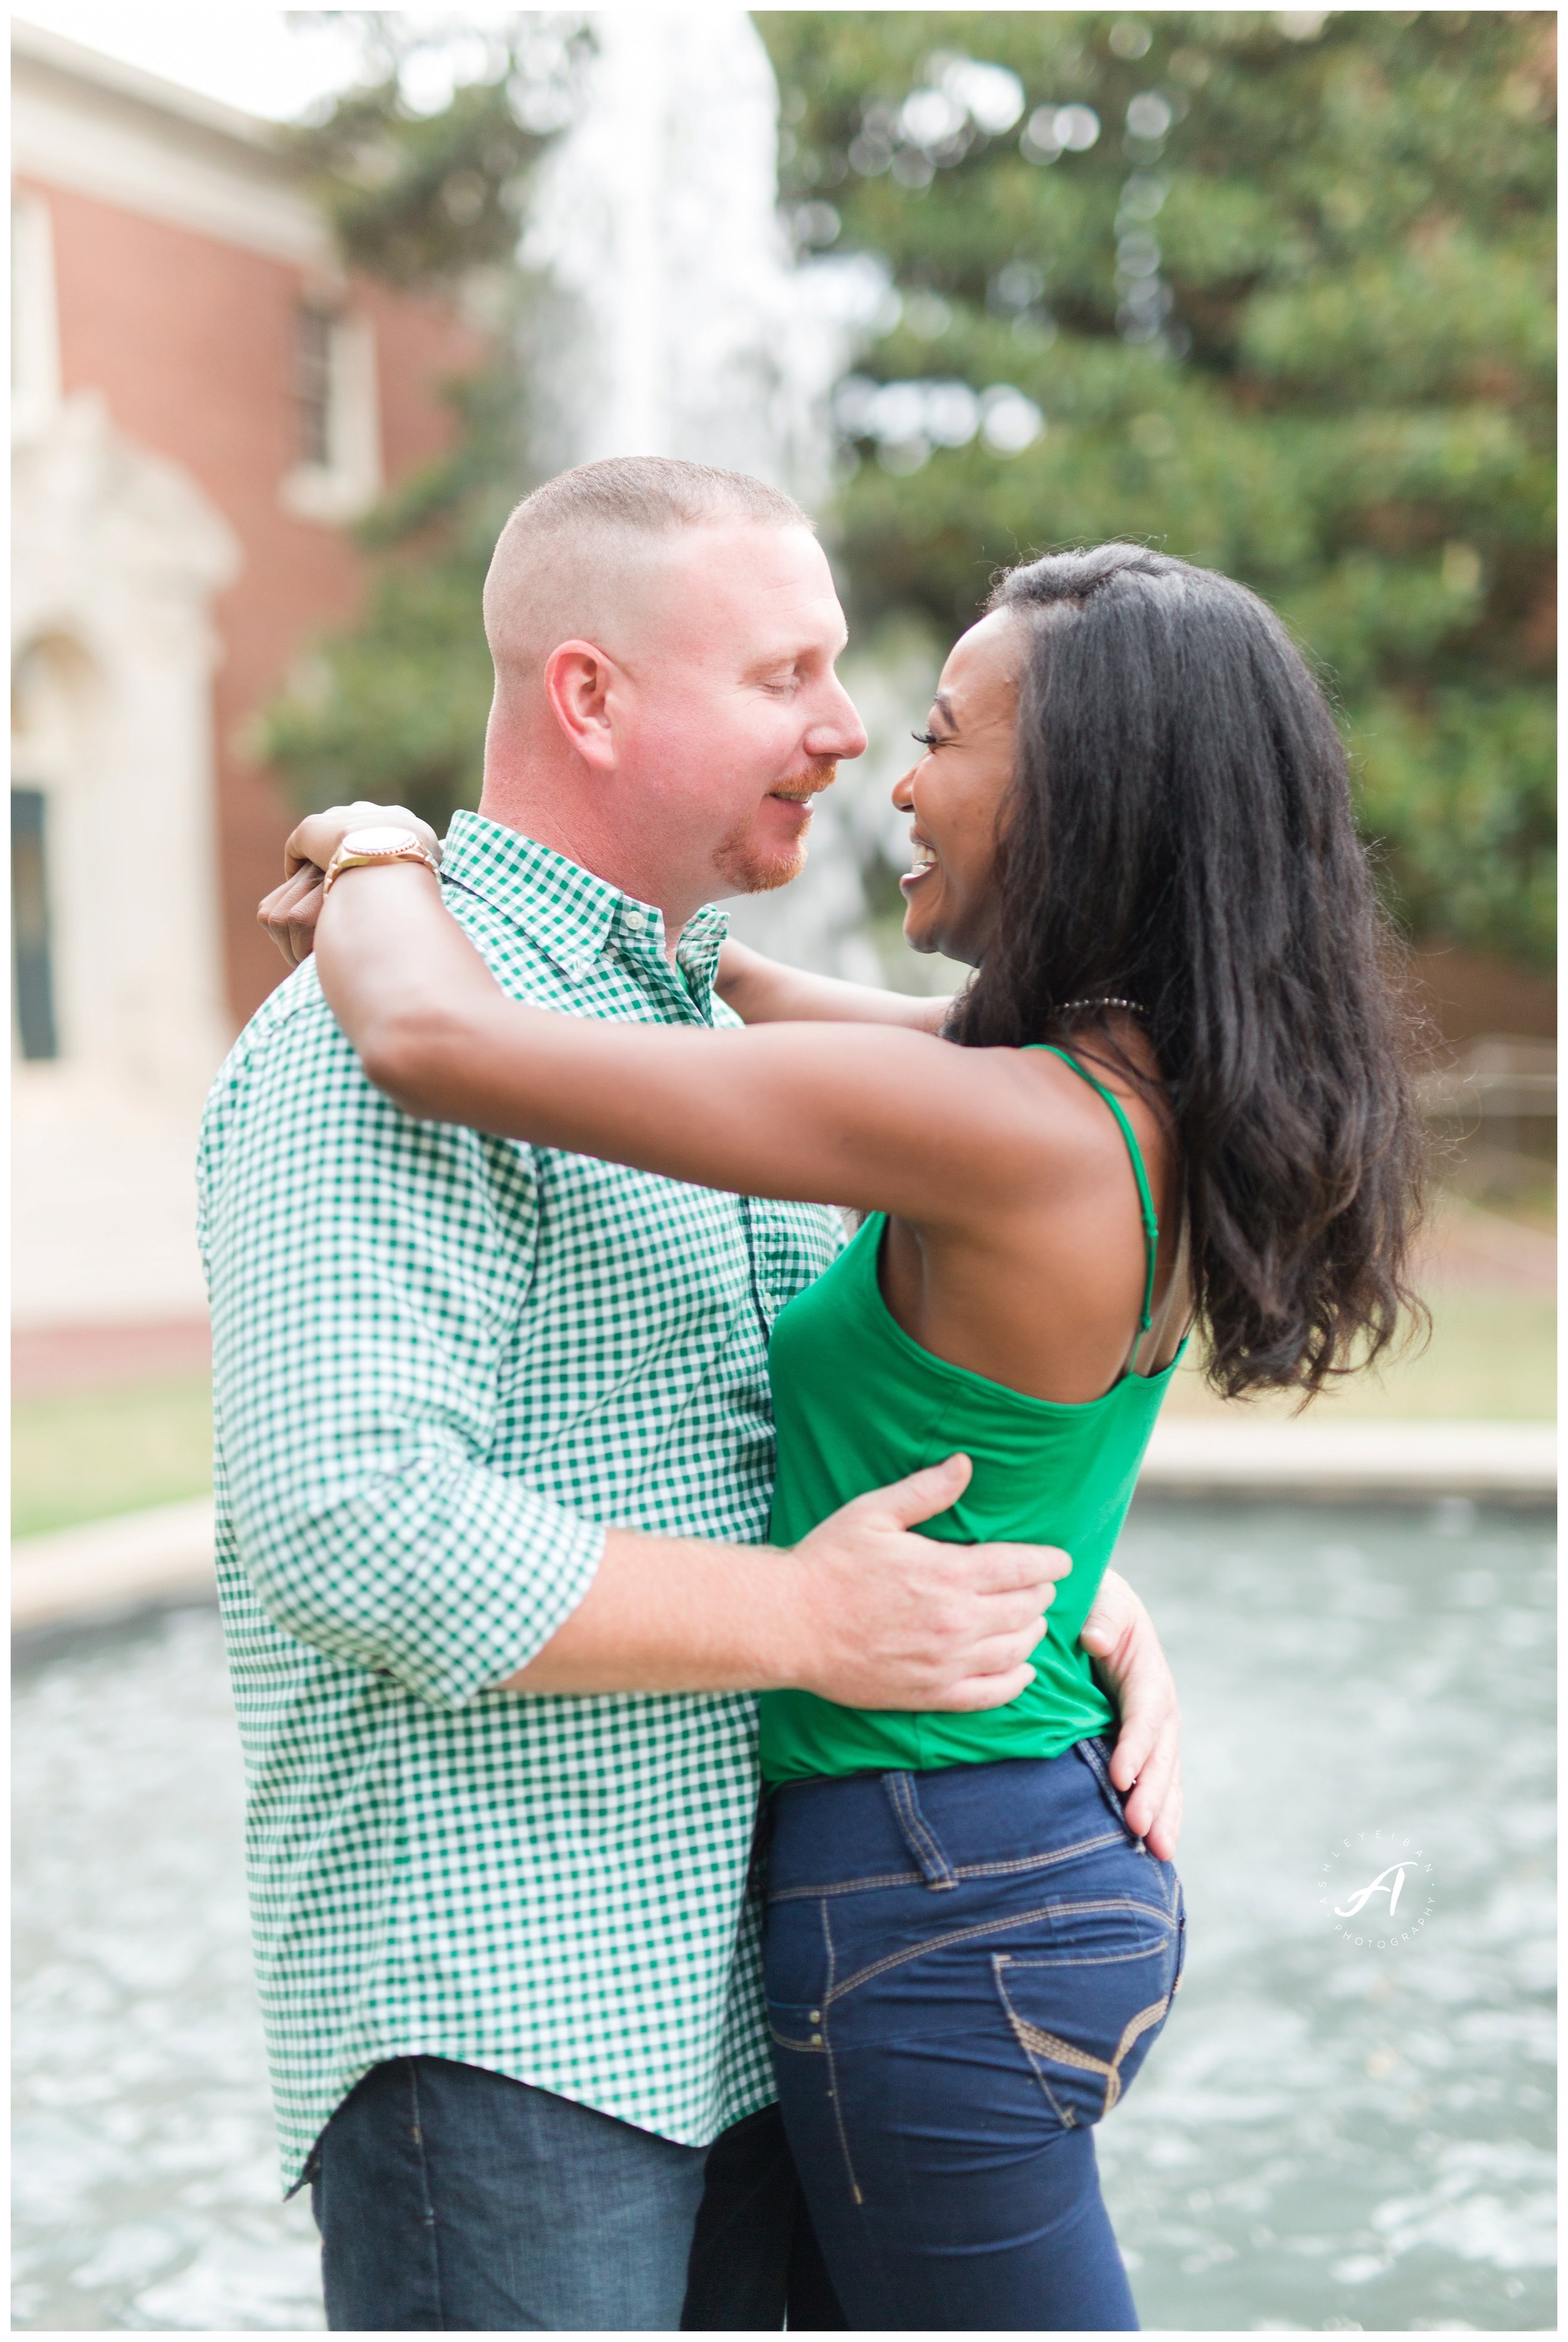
[756,9,1554,962]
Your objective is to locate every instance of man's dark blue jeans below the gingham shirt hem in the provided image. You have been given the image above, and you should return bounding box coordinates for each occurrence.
[311,2057,842,2333]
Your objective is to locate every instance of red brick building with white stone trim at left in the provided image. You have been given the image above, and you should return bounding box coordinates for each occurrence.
[12,26,482,1326]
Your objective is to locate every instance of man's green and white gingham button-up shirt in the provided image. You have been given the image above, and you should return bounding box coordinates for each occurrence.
[199,812,840,2185]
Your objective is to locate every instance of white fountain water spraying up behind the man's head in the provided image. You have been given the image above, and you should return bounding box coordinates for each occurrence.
[522,9,892,981]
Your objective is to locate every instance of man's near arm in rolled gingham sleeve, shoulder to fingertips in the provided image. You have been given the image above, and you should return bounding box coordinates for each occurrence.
[204,993,1067,1707]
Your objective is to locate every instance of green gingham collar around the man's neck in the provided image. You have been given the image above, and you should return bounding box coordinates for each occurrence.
[440,811,730,996]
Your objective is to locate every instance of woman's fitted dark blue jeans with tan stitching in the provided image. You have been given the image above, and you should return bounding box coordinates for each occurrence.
[765,1740,1184,2333]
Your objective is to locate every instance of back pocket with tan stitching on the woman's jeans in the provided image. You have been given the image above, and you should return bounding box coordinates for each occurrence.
[990,1895,1180,2129]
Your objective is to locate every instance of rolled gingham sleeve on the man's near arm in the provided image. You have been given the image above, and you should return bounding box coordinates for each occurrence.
[201,967,604,1710]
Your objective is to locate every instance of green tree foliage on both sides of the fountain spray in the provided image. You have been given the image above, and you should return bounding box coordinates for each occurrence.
[262,9,1554,965]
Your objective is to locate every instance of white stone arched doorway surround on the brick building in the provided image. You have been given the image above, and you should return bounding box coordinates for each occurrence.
[12,393,239,1326]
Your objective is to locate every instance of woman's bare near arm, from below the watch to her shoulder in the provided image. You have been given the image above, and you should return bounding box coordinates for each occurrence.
[316,862,1053,1225]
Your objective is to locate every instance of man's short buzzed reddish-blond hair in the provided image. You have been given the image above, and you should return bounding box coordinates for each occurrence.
[484,454,815,689]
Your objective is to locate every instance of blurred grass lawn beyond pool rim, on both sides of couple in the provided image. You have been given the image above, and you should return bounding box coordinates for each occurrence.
[12,1291,1556,1536]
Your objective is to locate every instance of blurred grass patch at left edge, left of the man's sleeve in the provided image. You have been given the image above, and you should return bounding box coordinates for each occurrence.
[12,1373,213,1536]
